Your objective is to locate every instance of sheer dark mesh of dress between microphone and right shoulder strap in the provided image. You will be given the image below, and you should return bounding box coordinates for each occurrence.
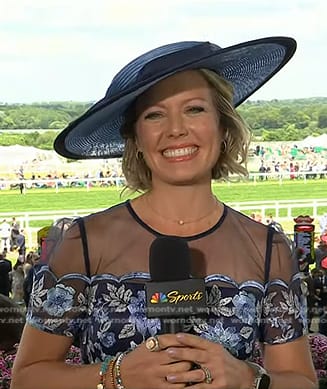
[189,207,267,285]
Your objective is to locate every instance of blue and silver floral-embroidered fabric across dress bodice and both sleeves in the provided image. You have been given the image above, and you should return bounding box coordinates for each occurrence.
[27,266,306,363]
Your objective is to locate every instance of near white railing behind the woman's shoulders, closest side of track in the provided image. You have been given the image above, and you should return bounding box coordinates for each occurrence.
[0,198,327,247]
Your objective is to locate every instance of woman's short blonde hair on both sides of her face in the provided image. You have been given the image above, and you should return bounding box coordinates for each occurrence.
[121,69,251,192]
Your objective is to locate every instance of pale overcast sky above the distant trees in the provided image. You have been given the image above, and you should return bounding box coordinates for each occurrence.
[0,0,327,103]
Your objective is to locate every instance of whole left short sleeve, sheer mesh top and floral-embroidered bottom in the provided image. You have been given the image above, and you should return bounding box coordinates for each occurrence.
[27,220,90,337]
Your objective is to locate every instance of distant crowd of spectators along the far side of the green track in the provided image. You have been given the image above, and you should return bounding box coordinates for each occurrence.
[0,142,327,190]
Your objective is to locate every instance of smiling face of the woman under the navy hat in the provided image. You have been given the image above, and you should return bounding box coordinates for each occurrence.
[136,70,223,186]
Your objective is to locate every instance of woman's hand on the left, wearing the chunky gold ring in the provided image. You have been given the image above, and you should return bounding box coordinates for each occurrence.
[120,334,192,389]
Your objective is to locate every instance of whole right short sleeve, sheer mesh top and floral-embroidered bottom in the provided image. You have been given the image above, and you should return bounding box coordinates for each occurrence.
[260,232,307,344]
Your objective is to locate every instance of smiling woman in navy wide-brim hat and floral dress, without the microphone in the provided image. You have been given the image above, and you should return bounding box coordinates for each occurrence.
[12,37,316,389]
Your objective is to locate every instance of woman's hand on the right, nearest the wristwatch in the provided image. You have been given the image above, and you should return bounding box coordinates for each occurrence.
[165,333,254,389]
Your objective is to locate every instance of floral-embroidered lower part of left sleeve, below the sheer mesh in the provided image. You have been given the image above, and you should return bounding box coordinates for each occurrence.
[26,266,89,338]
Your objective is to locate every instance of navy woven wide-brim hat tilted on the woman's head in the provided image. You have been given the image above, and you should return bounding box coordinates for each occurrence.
[54,37,296,159]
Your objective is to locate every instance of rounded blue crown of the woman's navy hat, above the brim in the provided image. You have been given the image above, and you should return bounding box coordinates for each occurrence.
[105,41,221,100]
